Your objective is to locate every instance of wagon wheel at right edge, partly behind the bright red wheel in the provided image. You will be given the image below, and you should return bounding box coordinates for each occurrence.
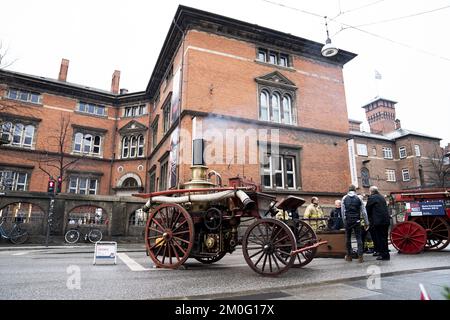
[410,216,450,251]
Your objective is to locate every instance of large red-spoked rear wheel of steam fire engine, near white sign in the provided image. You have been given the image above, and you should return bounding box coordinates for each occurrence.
[145,203,194,269]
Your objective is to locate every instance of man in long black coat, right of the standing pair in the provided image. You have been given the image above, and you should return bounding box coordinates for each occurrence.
[366,186,391,260]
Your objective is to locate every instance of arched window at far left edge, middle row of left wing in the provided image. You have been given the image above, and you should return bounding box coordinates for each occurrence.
[0,121,36,148]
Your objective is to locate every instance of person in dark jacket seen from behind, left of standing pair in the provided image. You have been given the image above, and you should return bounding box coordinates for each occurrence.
[341,185,369,263]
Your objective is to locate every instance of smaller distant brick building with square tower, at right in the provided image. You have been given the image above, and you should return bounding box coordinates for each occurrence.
[348,97,450,194]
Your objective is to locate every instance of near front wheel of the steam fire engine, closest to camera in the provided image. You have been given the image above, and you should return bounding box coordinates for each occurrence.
[242,219,297,276]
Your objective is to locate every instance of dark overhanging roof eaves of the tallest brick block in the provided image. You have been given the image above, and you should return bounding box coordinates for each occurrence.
[147,5,356,97]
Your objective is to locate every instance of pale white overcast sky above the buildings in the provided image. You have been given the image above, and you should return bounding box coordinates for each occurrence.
[0,0,450,145]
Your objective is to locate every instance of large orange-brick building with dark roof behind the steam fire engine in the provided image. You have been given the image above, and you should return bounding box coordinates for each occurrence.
[0,6,355,240]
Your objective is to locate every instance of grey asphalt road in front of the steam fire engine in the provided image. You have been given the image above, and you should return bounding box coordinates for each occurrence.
[0,245,450,300]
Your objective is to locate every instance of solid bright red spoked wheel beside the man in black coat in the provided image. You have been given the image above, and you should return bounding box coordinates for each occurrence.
[391,221,427,254]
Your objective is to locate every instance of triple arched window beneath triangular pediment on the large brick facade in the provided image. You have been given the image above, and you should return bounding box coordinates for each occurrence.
[259,89,295,124]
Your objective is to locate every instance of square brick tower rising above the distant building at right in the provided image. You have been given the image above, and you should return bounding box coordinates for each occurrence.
[363,98,397,134]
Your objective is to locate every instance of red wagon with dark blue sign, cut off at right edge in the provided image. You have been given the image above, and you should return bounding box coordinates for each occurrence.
[391,189,450,253]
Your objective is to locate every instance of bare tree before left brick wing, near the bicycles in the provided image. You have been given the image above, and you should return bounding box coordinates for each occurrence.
[37,113,83,186]
